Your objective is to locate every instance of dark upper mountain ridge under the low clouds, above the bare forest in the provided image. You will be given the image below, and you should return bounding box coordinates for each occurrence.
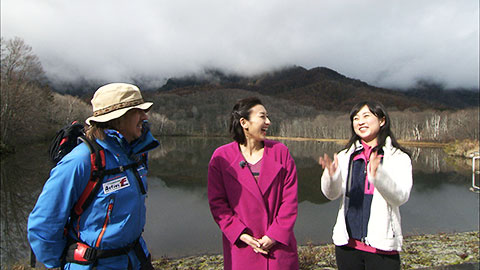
[158,66,479,111]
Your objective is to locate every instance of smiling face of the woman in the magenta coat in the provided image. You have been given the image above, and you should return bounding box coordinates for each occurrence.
[240,104,271,141]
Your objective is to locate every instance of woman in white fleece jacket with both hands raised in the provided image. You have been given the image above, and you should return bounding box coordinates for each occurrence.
[319,102,413,270]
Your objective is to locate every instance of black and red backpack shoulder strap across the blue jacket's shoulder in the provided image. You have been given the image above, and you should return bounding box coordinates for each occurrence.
[72,136,106,216]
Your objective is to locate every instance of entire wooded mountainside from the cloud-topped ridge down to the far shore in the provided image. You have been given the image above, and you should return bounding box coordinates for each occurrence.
[44,67,479,141]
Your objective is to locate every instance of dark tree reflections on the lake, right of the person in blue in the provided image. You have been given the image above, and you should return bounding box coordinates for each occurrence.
[150,137,471,201]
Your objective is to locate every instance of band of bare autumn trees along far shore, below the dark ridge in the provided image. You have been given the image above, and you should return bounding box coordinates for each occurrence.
[19,89,479,147]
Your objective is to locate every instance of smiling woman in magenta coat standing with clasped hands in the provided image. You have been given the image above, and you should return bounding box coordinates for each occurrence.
[208,98,298,270]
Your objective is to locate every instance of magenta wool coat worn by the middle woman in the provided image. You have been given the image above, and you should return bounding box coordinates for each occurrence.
[208,140,298,270]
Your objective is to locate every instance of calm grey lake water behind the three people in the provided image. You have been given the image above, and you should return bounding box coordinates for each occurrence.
[1,138,479,268]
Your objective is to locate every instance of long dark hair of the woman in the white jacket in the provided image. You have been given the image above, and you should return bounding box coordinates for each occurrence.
[345,101,410,155]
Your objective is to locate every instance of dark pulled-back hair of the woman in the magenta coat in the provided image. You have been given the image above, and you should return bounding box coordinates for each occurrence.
[229,97,263,144]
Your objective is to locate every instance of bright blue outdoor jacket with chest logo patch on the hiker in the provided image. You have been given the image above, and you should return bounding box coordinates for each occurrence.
[28,127,159,269]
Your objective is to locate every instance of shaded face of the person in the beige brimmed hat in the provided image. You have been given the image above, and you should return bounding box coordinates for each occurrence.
[116,109,148,142]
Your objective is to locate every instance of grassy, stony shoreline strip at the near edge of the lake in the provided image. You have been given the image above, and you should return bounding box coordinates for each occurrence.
[153,231,480,270]
